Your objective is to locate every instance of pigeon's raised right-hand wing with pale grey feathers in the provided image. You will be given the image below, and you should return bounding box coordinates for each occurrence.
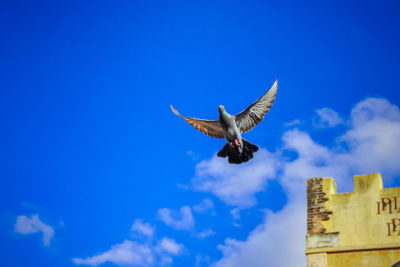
[235,80,278,133]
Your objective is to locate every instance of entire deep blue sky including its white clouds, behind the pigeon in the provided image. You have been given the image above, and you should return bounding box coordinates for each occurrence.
[0,1,400,267]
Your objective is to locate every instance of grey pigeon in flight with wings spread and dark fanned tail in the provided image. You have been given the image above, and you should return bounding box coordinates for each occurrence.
[171,80,278,164]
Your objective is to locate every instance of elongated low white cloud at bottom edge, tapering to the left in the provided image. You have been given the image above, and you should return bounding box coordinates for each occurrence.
[72,240,154,266]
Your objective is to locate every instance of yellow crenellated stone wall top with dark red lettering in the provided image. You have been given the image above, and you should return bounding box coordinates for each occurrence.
[306,173,400,267]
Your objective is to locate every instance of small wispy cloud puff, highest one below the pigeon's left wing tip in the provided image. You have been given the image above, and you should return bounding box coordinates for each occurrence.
[158,206,195,230]
